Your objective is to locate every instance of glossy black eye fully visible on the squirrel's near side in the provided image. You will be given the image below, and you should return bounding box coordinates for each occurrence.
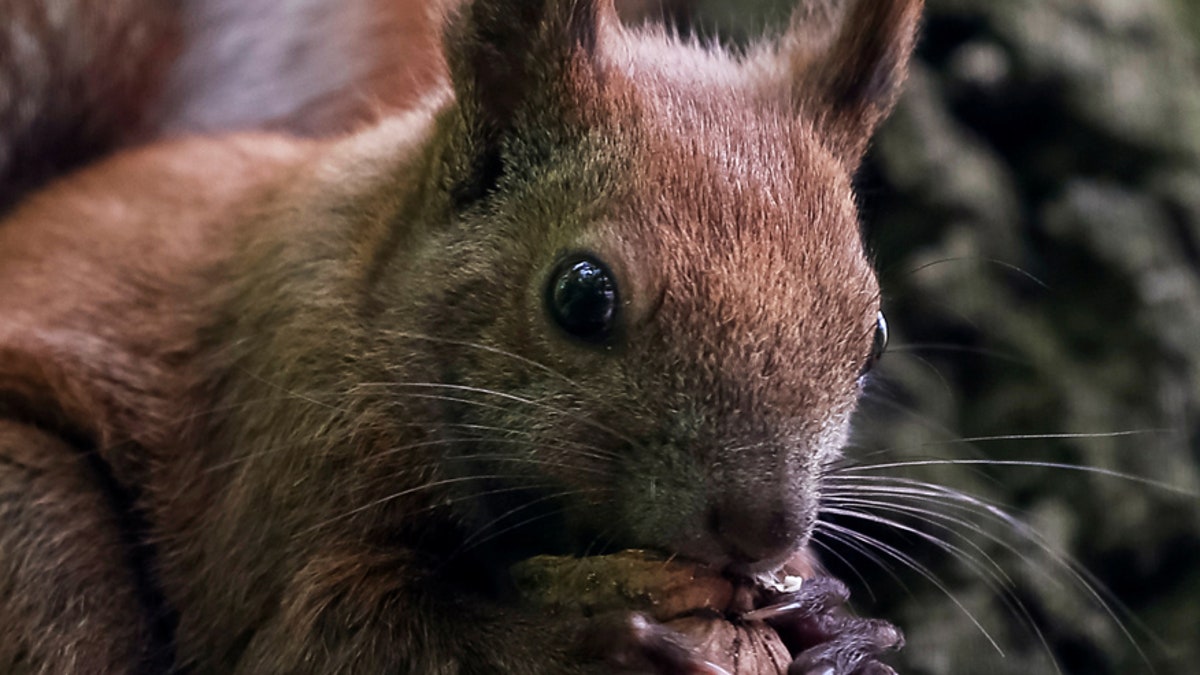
[546,257,617,342]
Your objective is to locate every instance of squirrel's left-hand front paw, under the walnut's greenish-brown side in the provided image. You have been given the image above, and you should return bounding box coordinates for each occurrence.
[580,611,728,675]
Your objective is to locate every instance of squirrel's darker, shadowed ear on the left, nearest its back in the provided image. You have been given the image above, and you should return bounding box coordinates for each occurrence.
[444,0,617,199]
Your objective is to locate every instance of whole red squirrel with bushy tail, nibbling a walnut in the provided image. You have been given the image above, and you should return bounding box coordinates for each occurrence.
[0,0,922,675]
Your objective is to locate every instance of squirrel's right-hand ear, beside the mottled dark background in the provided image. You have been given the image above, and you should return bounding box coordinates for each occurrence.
[784,0,924,168]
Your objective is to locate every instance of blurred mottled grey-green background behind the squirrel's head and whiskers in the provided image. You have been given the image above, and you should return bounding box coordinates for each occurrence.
[628,0,1200,675]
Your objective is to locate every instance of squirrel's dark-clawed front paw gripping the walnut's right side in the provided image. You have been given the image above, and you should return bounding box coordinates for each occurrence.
[746,577,904,675]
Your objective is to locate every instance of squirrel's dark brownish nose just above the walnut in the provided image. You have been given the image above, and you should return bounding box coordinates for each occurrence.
[709,498,811,565]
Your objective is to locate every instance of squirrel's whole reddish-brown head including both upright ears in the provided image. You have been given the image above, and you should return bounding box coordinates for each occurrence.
[343,0,922,569]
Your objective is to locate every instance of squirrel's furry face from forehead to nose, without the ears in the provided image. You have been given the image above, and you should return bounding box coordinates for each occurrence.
[403,102,878,566]
